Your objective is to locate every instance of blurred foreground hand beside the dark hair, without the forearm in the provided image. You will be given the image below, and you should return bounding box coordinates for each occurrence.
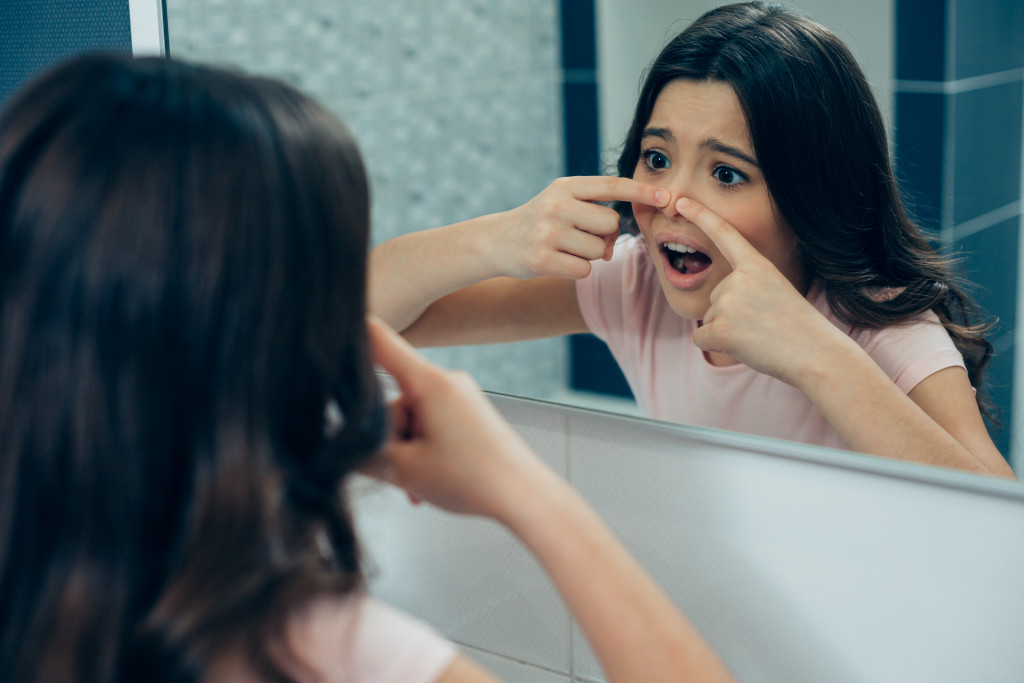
[369,318,548,520]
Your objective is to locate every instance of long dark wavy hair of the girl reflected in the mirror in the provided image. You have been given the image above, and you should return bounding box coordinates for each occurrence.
[614,2,992,417]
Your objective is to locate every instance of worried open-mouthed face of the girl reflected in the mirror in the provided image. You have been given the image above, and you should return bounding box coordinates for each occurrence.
[633,80,807,321]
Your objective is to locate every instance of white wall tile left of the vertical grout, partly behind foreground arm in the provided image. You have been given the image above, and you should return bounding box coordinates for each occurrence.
[353,397,569,675]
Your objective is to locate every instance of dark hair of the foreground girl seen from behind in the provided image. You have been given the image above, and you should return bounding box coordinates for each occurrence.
[0,54,386,683]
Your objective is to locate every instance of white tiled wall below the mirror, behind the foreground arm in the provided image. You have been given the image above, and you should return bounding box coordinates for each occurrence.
[353,396,1024,683]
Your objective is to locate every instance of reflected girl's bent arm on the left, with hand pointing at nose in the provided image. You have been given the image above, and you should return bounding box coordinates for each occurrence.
[369,176,668,346]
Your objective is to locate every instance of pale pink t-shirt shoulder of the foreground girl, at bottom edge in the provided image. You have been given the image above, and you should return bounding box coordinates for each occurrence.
[280,595,458,683]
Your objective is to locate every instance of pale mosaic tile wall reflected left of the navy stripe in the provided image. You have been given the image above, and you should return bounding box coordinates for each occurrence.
[167,0,568,397]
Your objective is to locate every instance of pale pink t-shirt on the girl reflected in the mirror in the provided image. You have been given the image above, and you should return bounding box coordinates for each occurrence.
[577,236,965,449]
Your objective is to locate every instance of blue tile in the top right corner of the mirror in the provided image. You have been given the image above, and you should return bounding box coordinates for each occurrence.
[950,0,1024,80]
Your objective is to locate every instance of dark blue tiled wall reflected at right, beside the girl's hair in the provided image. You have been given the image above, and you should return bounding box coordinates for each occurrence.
[894,0,1024,466]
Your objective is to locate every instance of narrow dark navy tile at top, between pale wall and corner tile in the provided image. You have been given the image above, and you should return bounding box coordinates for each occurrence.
[895,0,946,81]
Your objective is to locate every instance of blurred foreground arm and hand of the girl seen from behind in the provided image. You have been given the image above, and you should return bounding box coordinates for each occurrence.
[371,325,731,683]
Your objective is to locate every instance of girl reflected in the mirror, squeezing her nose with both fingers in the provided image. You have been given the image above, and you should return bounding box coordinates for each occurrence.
[371,2,1014,478]
